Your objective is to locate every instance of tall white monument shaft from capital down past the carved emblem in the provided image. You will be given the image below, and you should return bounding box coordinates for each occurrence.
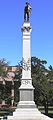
[22,23,31,79]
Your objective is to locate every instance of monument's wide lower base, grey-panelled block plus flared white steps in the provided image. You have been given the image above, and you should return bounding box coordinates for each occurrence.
[7,84,52,120]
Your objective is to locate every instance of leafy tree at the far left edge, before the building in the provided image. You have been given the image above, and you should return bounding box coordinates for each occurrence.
[0,58,8,103]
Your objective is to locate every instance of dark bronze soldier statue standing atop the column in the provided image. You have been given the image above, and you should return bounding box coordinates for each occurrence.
[24,2,32,22]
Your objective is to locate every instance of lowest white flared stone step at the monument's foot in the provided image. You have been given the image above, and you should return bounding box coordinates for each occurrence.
[8,108,52,120]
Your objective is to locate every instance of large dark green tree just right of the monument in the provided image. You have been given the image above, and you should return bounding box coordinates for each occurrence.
[31,57,51,114]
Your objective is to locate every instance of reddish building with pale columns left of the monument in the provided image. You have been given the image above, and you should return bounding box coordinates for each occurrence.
[0,66,20,107]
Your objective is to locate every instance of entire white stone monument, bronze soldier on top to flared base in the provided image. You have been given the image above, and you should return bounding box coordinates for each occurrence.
[8,2,51,120]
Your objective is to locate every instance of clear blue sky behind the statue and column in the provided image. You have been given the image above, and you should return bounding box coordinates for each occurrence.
[0,0,53,66]
